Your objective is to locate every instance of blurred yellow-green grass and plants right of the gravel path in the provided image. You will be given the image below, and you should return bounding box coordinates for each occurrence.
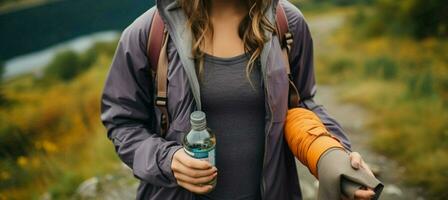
[312,5,448,199]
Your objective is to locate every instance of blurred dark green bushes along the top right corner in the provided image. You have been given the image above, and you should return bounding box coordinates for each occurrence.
[298,0,448,39]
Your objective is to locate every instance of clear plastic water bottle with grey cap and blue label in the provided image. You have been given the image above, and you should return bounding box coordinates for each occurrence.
[183,111,216,187]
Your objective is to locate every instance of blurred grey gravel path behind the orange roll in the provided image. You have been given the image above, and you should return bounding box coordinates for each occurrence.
[298,86,423,200]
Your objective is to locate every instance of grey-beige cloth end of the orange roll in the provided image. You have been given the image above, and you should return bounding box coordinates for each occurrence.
[317,148,384,200]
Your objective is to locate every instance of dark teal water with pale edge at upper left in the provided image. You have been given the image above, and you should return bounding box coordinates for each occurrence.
[0,0,155,78]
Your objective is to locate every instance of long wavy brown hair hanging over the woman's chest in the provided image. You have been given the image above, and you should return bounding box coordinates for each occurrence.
[178,0,275,84]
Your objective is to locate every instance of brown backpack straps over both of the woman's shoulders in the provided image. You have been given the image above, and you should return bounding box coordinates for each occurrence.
[146,4,300,136]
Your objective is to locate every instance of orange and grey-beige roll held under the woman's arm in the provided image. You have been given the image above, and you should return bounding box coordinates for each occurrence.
[285,108,383,199]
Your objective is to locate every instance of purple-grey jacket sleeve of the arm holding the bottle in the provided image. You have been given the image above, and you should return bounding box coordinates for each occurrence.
[101,9,181,187]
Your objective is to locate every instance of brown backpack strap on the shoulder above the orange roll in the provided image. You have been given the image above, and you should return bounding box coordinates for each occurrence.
[276,3,300,108]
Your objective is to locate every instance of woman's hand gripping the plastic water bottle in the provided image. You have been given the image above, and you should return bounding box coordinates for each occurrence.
[171,148,218,194]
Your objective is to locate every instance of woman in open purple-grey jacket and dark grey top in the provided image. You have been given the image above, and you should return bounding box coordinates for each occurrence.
[101,0,373,199]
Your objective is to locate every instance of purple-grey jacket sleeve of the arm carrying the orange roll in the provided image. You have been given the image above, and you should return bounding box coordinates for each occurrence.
[280,1,351,151]
